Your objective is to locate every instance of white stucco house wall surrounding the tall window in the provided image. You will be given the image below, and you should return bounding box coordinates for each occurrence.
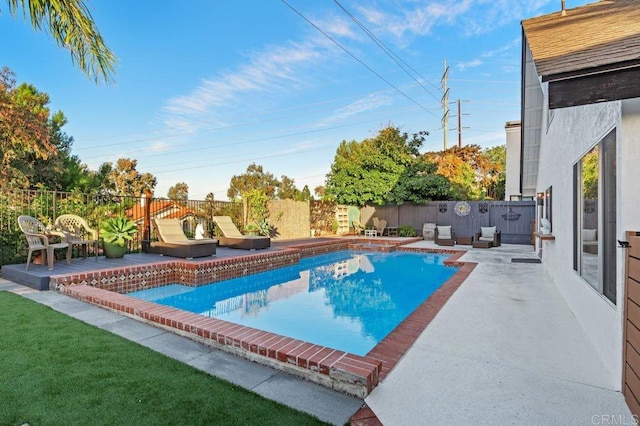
[537,95,624,390]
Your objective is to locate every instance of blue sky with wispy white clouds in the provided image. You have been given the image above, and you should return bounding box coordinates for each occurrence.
[0,0,588,200]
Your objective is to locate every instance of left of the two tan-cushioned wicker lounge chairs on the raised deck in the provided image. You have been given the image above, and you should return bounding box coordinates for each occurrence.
[142,219,218,259]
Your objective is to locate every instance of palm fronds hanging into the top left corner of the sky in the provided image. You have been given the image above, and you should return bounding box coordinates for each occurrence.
[7,0,116,83]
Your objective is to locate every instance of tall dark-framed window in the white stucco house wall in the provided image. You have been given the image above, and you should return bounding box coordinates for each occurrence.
[573,131,616,303]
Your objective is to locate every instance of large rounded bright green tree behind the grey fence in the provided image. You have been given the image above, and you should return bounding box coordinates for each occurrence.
[325,126,427,206]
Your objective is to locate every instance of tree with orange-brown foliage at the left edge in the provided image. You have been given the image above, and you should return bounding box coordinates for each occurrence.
[0,67,56,187]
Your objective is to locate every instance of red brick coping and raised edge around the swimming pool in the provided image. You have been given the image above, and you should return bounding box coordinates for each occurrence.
[57,238,475,398]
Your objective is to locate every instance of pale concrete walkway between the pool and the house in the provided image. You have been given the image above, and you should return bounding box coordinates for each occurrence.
[365,242,636,425]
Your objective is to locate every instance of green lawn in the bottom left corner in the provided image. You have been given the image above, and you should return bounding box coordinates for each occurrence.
[0,292,322,426]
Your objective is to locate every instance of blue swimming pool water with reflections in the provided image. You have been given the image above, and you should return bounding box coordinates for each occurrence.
[129,251,457,355]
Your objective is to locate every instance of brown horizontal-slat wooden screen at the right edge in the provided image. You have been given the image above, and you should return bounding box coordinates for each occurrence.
[622,231,640,415]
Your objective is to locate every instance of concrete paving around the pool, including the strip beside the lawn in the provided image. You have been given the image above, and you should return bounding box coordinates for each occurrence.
[0,238,635,425]
